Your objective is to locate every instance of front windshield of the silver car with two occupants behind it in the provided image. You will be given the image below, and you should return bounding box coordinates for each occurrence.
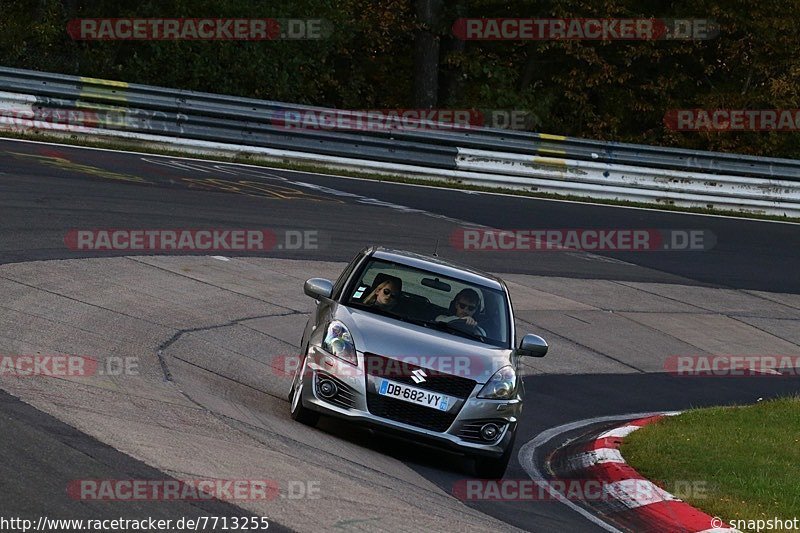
[343,259,510,348]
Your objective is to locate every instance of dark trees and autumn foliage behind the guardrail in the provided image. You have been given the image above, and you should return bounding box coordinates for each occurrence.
[0,0,800,157]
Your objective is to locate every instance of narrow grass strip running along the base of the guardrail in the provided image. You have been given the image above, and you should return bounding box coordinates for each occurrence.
[0,131,800,223]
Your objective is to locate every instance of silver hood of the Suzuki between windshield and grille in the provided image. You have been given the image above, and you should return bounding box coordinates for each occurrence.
[336,306,512,383]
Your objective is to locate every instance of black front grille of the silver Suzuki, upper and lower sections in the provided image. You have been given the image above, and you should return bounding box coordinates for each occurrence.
[365,353,476,433]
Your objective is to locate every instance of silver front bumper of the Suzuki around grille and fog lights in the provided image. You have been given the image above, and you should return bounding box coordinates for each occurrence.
[301,345,522,457]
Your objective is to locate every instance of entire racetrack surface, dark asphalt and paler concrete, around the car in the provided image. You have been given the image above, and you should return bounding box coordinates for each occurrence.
[0,140,800,531]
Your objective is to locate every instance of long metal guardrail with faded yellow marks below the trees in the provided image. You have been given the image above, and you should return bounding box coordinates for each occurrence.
[0,67,800,216]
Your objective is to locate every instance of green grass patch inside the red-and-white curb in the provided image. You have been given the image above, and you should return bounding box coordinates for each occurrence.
[621,396,800,521]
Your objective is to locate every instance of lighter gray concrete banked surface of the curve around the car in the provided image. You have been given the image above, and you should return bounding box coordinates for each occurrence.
[0,257,800,531]
